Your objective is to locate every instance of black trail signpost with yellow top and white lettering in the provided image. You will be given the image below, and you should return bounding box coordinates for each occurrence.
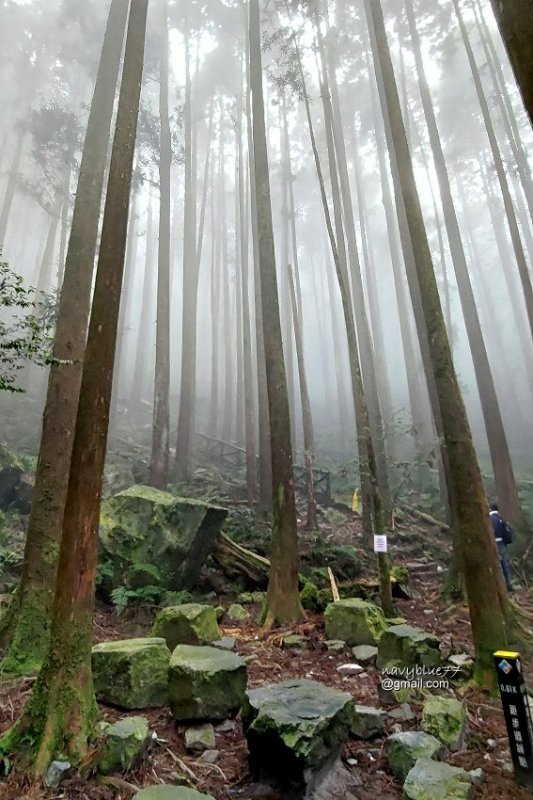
[494,650,533,786]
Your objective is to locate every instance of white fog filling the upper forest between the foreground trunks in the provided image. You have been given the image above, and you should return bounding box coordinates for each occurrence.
[0,0,533,504]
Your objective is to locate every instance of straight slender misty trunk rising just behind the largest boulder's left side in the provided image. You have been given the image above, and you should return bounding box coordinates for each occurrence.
[149,0,172,489]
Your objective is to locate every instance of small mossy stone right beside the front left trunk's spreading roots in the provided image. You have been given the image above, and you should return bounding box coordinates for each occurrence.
[97,717,150,775]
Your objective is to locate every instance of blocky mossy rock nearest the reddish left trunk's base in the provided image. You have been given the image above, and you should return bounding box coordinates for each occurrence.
[91,639,170,709]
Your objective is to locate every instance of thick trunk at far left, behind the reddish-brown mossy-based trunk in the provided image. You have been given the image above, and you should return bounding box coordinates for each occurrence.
[0,0,129,674]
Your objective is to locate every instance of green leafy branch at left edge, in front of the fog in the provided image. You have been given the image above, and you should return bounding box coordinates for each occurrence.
[0,253,59,392]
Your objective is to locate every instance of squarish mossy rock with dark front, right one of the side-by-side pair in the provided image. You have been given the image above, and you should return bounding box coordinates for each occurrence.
[168,644,247,720]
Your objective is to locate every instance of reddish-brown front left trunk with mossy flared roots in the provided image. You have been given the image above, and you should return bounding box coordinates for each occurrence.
[0,0,148,775]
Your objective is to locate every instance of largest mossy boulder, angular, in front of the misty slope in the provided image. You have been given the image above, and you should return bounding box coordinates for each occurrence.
[100,486,227,591]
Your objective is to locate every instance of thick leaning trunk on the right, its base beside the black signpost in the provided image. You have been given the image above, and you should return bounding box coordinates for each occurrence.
[365,0,509,687]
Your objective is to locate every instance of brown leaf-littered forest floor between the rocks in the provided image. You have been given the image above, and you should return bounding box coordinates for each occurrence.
[0,506,533,800]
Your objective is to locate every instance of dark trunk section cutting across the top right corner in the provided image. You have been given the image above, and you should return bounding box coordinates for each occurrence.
[491,0,533,124]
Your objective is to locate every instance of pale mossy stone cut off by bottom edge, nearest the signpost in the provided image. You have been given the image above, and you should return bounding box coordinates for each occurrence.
[403,758,472,800]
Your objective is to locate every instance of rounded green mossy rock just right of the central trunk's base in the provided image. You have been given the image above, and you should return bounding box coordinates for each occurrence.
[324,597,387,647]
